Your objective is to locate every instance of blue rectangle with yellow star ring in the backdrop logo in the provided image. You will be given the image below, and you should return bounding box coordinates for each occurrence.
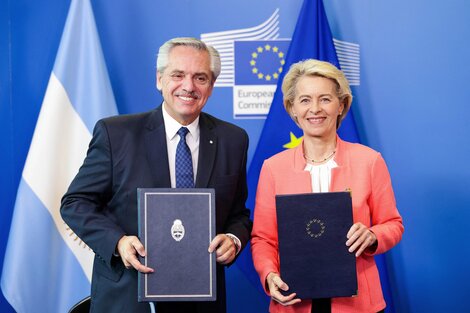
[234,40,290,85]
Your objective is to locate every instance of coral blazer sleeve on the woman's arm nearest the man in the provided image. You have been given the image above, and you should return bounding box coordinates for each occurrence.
[251,161,280,294]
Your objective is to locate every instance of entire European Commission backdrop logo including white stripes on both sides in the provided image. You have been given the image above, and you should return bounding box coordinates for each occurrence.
[201,9,360,119]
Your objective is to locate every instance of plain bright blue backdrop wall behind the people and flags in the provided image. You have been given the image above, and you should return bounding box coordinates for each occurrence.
[0,0,470,313]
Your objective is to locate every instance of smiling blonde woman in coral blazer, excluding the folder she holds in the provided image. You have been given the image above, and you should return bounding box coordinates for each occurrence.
[251,60,404,313]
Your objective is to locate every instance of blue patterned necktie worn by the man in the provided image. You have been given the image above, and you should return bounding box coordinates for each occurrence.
[175,127,194,188]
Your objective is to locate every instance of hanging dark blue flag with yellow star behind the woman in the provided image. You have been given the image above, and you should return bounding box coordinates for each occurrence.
[238,0,393,312]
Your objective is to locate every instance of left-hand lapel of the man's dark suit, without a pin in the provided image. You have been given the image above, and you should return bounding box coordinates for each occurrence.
[145,106,171,188]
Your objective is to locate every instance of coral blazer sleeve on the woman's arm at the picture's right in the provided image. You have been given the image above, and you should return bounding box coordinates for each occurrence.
[369,153,404,254]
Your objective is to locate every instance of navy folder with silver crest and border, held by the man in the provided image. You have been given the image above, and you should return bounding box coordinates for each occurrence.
[137,188,217,301]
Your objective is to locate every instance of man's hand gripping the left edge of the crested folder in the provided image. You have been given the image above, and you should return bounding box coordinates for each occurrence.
[117,236,154,273]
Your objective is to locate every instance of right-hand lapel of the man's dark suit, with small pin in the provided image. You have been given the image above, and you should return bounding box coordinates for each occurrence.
[195,113,217,188]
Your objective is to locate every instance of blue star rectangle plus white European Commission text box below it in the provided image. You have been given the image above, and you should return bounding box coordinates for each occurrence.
[233,40,290,118]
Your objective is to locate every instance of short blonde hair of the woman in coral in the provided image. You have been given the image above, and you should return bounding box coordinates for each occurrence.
[282,59,352,129]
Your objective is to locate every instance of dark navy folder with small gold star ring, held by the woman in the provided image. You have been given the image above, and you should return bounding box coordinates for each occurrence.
[276,192,357,299]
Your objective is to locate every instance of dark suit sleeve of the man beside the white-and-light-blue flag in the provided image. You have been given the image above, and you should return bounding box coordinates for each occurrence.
[60,121,125,267]
